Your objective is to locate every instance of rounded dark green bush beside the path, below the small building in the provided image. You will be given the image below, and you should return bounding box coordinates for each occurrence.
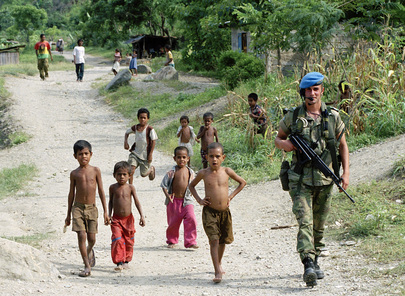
[218,50,264,89]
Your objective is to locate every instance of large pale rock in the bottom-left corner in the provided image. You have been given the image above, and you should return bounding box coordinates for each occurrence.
[0,238,60,281]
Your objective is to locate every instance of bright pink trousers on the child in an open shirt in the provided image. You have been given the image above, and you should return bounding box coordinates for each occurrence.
[166,198,197,248]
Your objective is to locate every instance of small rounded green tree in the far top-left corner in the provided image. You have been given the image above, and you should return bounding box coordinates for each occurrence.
[11,5,48,43]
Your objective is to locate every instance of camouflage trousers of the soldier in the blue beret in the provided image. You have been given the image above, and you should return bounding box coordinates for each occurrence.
[289,182,333,261]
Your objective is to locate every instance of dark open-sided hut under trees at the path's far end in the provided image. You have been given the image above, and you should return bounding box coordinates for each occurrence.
[124,35,177,59]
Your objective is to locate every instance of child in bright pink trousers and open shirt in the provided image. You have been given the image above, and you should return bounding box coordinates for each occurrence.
[160,146,198,249]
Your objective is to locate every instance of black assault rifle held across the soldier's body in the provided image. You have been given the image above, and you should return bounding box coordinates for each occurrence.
[290,135,355,203]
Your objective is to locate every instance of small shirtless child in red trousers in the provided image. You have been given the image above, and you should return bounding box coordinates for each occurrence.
[108,161,145,271]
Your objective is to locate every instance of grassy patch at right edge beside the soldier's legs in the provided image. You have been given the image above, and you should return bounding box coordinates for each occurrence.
[328,158,405,277]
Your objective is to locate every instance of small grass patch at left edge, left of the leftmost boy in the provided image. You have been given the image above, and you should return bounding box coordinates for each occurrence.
[0,164,38,200]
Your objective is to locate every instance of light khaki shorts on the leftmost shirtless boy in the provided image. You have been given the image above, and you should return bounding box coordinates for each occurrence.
[72,202,98,233]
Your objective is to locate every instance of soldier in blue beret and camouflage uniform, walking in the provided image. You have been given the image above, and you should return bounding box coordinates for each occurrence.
[275,72,350,286]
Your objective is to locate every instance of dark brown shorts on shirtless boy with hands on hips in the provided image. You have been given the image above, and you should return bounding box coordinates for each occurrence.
[202,206,233,244]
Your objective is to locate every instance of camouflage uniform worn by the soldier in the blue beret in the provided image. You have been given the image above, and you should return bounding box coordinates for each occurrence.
[280,102,345,261]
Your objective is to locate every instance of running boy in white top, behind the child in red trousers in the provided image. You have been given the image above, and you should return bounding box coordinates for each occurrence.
[124,108,158,184]
